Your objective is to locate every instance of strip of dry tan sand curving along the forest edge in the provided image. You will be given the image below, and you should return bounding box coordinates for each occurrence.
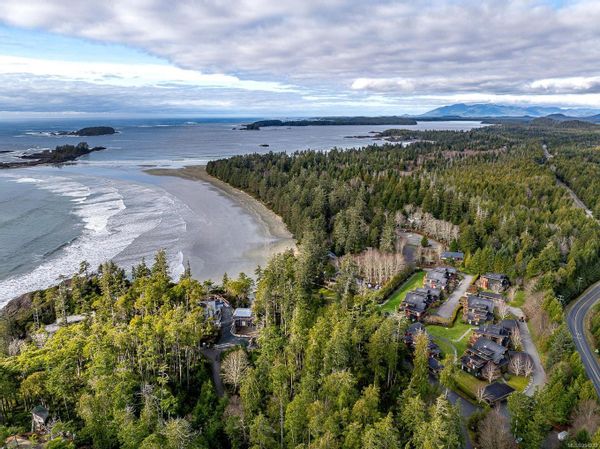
[144,165,296,250]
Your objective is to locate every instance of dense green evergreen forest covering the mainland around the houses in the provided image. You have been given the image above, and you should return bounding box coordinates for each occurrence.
[0,123,600,449]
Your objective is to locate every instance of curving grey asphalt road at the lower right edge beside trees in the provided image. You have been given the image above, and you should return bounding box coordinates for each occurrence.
[567,282,600,397]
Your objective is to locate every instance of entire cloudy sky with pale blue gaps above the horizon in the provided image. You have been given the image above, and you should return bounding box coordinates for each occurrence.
[0,0,600,117]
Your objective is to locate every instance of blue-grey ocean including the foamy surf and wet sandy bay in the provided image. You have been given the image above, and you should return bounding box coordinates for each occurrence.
[0,118,483,307]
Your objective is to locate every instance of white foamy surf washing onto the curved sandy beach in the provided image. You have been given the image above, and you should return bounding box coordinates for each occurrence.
[0,175,185,307]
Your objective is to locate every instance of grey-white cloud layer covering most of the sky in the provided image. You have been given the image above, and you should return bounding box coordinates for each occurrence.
[0,0,600,112]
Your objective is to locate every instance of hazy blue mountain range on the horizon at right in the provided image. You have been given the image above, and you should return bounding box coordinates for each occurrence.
[422,103,600,120]
